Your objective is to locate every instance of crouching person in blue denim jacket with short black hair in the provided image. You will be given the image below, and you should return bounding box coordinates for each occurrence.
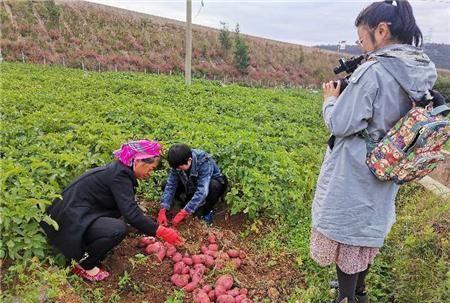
[158,144,228,226]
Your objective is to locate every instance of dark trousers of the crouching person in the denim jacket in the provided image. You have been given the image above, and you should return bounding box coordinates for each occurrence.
[162,176,228,216]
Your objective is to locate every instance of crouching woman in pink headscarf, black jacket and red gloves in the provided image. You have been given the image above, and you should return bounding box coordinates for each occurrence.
[41,140,182,281]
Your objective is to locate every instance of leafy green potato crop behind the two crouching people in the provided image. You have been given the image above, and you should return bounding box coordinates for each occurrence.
[0,63,326,258]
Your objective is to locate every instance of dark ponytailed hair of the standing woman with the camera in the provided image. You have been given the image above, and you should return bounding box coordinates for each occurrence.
[355,1,423,46]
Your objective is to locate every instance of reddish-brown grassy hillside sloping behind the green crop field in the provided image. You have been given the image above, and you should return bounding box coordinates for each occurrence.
[0,1,346,86]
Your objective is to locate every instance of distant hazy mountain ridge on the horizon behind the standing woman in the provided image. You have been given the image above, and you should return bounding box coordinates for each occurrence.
[315,43,450,70]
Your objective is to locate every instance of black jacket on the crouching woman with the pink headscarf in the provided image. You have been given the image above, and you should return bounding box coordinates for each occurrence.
[41,161,158,261]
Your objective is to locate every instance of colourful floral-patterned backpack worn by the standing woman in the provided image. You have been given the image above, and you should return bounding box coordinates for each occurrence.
[360,95,450,184]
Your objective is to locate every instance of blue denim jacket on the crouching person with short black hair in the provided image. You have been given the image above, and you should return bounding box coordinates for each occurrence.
[161,149,222,214]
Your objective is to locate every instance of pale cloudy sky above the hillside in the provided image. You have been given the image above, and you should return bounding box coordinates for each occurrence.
[89,0,450,45]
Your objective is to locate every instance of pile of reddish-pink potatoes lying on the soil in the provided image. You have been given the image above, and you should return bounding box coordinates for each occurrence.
[138,234,252,303]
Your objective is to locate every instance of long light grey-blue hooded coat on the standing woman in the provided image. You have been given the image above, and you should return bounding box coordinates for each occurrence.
[312,44,437,247]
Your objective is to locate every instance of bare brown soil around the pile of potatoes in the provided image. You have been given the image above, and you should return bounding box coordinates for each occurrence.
[69,202,304,303]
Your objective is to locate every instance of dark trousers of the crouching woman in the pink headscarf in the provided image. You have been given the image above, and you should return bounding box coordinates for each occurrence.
[80,217,127,270]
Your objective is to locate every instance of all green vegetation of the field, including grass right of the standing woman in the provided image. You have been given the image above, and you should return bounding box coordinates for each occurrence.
[0,63,450,303]
